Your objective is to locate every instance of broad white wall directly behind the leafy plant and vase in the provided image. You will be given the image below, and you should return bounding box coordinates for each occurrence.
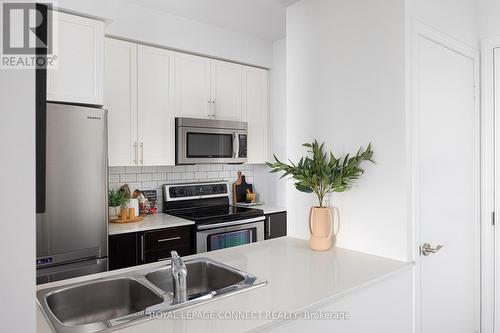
[287,0,407,259]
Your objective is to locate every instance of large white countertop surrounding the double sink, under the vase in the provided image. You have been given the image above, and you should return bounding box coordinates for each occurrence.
[37,237,411,333]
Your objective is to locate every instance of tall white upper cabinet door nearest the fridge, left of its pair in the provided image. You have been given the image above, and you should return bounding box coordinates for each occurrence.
[104,38,139,166]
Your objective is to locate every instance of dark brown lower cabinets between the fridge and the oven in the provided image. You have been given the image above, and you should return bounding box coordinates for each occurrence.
[109,226,196,270]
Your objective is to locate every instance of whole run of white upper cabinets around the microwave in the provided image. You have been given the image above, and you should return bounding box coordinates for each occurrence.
[104,38,269,166]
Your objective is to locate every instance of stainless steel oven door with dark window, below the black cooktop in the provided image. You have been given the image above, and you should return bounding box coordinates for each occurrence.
[196,216,265,253]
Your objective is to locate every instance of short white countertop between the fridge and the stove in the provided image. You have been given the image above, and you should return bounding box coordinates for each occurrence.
[108,213,194,235]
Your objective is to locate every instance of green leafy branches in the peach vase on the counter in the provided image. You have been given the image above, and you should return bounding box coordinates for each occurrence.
[266,140,374,207]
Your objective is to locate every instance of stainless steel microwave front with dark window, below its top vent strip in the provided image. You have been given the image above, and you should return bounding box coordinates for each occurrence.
[175,127,247,164]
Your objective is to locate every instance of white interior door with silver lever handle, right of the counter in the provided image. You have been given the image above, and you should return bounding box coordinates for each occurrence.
[412,26,480,333]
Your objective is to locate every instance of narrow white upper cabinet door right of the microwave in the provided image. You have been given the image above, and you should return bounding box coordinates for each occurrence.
[243,66,269,164]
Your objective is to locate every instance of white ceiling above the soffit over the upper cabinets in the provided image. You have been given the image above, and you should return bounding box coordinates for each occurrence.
[125,0,299,41]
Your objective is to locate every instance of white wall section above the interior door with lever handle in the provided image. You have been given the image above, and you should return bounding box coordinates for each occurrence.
[406,0,478,47]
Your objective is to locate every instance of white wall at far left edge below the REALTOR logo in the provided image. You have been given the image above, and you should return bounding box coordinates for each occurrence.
[0,55,35,332]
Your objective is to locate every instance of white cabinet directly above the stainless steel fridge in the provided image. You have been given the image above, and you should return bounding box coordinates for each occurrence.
[47,12,104,105]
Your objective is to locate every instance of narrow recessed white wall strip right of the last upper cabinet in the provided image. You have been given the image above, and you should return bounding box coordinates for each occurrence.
[254,39,286,207]
